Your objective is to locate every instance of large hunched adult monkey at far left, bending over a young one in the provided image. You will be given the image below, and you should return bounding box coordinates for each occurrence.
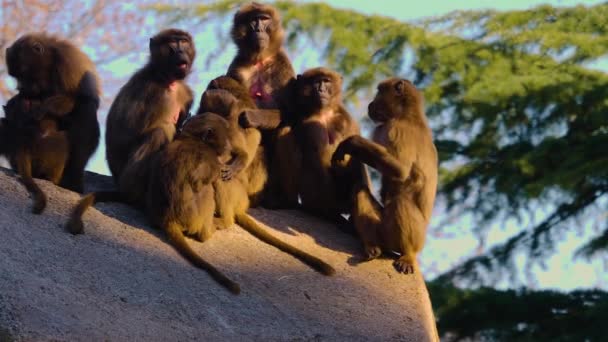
[6,33,100,193]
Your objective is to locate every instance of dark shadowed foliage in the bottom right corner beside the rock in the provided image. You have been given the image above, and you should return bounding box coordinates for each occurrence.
[428,282,608,341]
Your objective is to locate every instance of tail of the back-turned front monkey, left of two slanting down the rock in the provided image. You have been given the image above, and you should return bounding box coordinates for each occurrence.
[165,223,241,294]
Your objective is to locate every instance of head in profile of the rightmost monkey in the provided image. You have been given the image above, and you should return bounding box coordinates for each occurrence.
[367,78,422,122]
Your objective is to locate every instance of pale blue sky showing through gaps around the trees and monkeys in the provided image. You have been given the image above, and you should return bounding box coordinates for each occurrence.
[76,0,608,290]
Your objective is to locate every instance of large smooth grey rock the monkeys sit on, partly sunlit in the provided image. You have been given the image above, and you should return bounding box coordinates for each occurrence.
[0,169,437,341]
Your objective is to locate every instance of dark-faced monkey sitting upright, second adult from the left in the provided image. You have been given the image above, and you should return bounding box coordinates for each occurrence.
[106,29,196,203]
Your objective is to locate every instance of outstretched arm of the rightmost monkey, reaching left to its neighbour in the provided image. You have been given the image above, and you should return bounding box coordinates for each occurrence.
[332,135,412,180]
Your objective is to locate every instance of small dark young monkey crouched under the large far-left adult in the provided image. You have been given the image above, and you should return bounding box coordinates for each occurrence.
[0,95,71,214]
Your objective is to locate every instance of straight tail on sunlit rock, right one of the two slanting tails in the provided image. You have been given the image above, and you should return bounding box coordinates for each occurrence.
[236,214,336,276]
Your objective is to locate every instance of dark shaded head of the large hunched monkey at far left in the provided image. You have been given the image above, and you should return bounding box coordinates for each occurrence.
[6,35,54,97]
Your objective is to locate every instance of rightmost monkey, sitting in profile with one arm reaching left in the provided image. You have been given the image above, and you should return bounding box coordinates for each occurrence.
[332,78,438,274]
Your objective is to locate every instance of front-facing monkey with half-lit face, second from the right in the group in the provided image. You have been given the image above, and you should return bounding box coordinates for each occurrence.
[291,68,368,224]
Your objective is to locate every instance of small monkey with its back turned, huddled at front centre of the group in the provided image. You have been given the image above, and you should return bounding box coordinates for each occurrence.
[67,113,240,294]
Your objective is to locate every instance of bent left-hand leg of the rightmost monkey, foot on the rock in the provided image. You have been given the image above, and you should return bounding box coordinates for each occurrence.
[350,186,382,260]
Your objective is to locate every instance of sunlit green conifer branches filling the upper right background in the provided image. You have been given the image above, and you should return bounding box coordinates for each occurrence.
[148,1,608,281]
